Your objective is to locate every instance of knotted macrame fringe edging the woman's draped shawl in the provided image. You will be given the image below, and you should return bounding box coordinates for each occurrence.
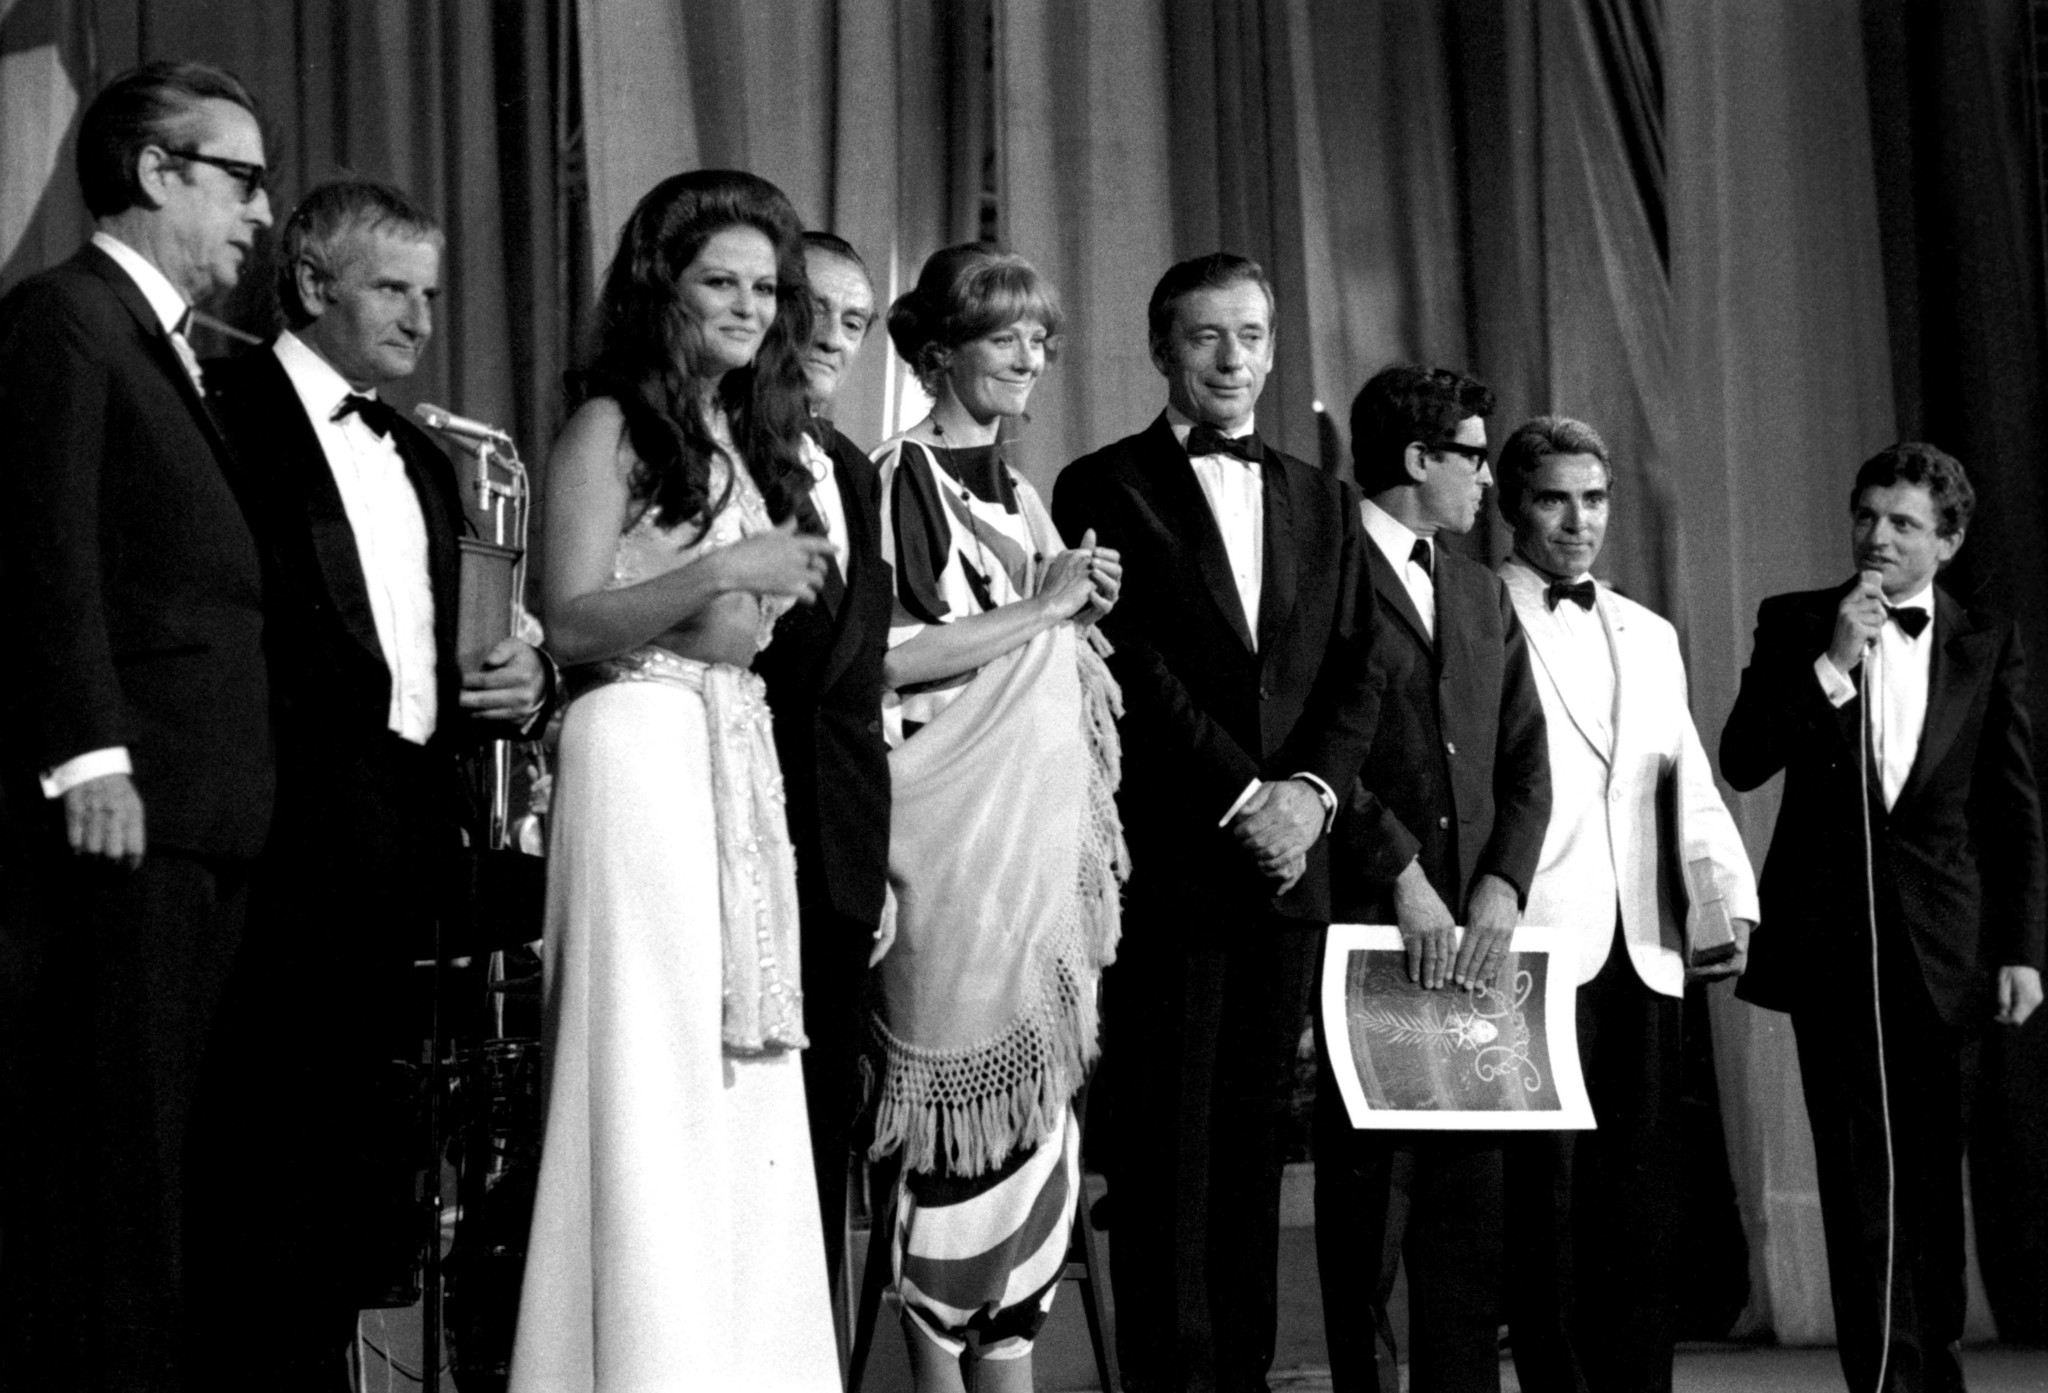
[860,629,1130,1176]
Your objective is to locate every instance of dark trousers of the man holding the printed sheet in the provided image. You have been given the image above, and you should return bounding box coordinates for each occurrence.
[1315,1022,1501,1393]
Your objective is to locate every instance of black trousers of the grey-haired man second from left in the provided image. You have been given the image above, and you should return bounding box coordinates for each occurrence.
[197,735,459,1393]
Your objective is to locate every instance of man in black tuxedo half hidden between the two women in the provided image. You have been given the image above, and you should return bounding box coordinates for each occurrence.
[754,231,891,1309]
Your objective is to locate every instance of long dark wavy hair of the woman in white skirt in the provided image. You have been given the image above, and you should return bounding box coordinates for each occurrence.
[567,170,811,526]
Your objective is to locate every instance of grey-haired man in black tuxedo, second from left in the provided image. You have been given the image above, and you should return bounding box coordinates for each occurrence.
[209,182,549,1389]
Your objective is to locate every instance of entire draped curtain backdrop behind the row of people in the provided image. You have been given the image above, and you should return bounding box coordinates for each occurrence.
[0,0,2048,1342]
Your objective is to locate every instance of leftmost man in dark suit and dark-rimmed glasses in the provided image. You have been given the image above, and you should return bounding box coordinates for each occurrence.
[0,64,274,1393]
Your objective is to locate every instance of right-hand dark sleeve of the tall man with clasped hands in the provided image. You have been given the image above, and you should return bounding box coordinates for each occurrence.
[1270,481,1380,799]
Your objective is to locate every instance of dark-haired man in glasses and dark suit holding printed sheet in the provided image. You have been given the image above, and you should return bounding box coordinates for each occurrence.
[1315,367,1550,1393]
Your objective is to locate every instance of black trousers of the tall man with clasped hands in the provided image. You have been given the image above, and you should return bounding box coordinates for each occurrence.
[1104,916,1321,1393]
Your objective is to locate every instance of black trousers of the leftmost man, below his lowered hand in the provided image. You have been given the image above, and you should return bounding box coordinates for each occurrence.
[0,846,250,1393]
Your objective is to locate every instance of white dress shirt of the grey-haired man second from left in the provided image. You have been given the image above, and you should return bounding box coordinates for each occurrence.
[276,330,440,746]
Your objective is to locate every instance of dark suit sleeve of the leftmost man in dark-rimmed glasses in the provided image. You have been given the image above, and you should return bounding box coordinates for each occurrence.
[0,276,133,770]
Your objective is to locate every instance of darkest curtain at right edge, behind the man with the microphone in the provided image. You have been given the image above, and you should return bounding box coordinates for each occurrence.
[1862,0,2048,1344]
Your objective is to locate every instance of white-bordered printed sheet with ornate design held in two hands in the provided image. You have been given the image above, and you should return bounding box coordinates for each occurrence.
[1321,924,1593,1131]
